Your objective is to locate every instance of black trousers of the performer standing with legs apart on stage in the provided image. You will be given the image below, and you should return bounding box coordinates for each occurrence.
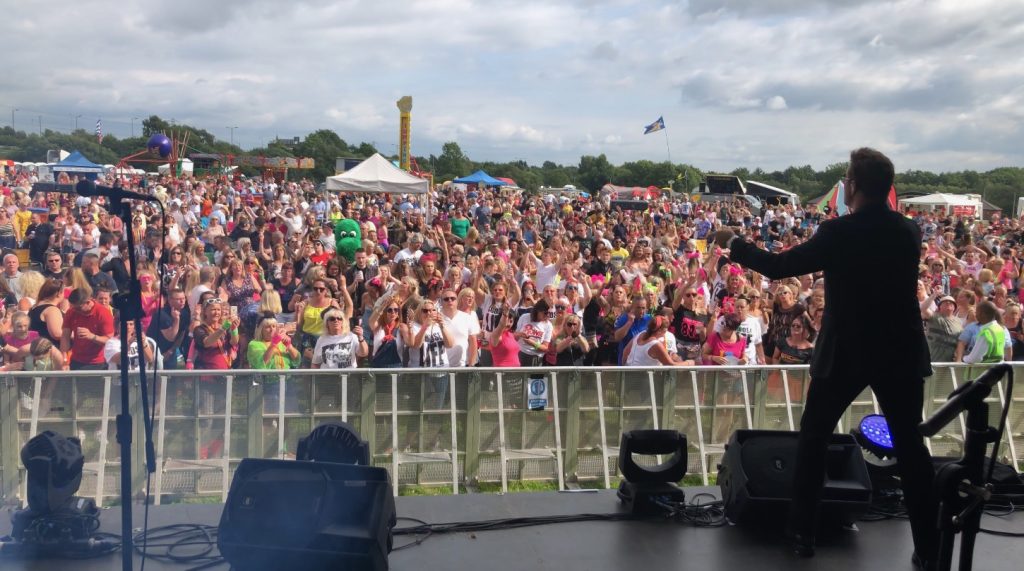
[790,375,938,561]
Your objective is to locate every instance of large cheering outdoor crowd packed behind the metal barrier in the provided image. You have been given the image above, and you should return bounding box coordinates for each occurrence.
[0,165,1024,380]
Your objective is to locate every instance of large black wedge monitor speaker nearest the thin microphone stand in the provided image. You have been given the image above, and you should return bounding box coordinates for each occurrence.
[217,458,395,571]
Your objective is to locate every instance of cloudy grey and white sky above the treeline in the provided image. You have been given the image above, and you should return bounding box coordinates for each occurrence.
[0,0,1024,171]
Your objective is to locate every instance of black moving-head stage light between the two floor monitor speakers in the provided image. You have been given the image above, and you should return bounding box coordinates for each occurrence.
[618,430,686,514]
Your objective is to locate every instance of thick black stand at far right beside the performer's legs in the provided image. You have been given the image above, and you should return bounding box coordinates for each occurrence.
[919,365,1009,571]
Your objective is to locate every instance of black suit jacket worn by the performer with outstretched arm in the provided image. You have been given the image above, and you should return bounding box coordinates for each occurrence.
[730,204,932,382]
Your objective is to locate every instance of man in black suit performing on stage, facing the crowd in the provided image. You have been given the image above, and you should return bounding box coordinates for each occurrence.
[715,148,938,568]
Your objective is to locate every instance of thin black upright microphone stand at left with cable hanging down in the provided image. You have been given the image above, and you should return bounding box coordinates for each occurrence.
[106,189,157,571]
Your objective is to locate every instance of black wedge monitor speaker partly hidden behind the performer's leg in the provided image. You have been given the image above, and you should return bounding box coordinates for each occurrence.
[718,430,871,525]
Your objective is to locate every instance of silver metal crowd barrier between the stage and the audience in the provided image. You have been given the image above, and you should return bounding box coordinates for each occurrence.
[0,364,1024,503]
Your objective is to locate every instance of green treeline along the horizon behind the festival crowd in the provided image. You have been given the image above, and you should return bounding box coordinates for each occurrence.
[0,116,1024,213]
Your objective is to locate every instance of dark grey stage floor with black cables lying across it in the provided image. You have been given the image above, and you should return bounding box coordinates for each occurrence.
[0,487,1024,571]
